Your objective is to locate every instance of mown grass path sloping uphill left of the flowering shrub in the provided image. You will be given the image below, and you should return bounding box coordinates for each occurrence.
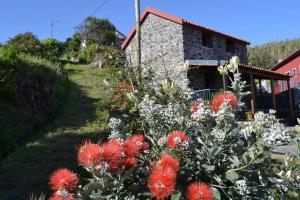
[0,64,111,200]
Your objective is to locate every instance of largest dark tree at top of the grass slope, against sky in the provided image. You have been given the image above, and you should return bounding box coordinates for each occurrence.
[77,17,116,45]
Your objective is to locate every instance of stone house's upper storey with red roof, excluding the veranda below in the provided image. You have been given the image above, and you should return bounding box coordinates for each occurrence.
[122,8,249,80]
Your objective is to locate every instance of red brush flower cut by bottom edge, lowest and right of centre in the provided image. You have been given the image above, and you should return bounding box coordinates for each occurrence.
[186,183,213,200]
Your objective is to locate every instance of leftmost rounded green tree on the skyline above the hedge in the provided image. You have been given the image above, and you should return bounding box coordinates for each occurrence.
[7,32,41,56]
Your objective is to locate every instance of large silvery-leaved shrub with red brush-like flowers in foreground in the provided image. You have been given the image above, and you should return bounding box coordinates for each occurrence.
[48,57,300,200]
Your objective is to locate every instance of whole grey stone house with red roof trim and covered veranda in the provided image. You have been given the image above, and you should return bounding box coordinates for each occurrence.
[121,8,289,117]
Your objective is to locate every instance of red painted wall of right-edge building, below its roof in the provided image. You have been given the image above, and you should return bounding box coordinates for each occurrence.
[274,56,300,93]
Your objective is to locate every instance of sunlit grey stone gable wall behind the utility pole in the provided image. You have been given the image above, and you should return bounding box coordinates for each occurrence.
[125,14,184,69]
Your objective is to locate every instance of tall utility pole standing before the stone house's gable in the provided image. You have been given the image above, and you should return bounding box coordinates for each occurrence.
[135,0,142,84]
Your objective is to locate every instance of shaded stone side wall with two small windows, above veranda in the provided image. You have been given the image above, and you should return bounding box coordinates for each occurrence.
[183,26,248,64]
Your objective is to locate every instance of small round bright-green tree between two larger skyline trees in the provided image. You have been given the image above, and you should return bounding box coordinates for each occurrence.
[42,38,64,61]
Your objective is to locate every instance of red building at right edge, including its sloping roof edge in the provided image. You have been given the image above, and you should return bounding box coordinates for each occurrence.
[272,49,300,93]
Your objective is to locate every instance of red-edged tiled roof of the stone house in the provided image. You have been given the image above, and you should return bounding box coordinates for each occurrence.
[121,8,250,50]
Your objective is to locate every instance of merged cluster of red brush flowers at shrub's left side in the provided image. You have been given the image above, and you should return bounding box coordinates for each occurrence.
[78,134,148,173]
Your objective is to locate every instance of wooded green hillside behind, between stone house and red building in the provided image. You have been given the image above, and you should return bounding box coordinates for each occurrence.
[248,38,300,68]
